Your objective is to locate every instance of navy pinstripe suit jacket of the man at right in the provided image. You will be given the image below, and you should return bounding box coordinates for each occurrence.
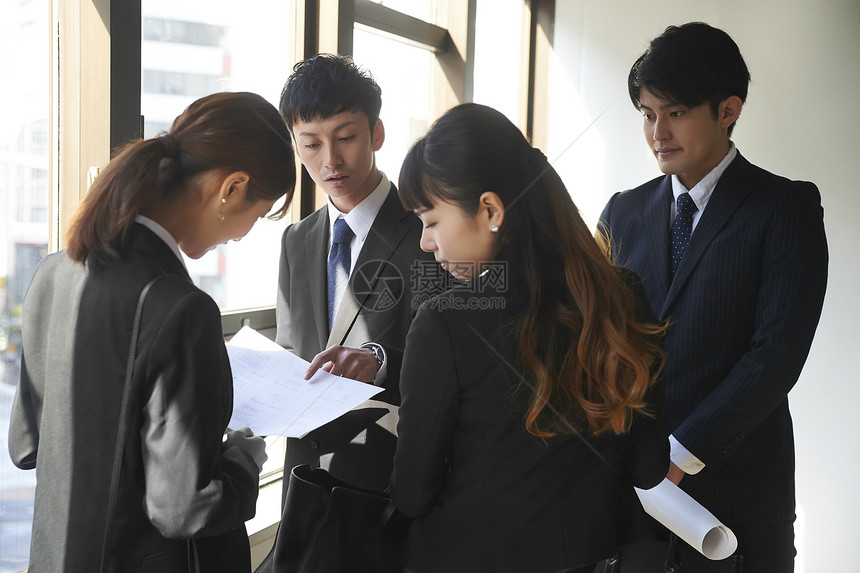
[601,154,828,527]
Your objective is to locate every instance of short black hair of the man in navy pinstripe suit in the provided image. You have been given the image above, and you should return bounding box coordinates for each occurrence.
[627,22,750,135]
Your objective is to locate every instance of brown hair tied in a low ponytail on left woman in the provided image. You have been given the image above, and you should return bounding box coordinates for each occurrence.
[66,92,296,262]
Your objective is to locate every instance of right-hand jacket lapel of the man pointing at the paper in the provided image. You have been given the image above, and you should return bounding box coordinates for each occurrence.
[325,184,410,348]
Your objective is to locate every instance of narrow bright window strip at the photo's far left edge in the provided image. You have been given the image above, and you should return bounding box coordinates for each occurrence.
[0,2,50,573]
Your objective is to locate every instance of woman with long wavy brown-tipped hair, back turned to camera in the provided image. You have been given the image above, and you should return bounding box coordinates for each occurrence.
[391,104,669,573]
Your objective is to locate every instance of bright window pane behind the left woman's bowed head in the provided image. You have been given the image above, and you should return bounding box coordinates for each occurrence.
[141,0,295,310]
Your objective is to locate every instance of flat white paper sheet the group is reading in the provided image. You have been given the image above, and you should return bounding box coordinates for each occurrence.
[227,326,382,438]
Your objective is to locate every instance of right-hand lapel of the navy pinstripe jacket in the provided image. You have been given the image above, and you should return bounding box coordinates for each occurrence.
[660,153,752,317]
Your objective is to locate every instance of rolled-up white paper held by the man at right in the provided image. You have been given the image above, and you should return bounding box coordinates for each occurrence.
[633,478,738,560]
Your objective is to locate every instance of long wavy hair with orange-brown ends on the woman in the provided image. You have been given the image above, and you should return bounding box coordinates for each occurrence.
[398,103,665,438]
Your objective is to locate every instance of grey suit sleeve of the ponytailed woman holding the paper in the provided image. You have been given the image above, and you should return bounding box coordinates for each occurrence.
[141,292,259,538]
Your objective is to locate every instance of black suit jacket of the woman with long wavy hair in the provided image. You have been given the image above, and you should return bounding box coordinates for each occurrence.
[391,274,669,573]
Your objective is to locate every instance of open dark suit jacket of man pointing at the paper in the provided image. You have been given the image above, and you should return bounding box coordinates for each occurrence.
[276,184,438,490]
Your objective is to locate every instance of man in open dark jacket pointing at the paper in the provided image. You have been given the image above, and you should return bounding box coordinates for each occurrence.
[276,55,436,490]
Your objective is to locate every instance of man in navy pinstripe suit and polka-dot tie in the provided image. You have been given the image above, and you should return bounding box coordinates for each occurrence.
[600,23,828,573]
